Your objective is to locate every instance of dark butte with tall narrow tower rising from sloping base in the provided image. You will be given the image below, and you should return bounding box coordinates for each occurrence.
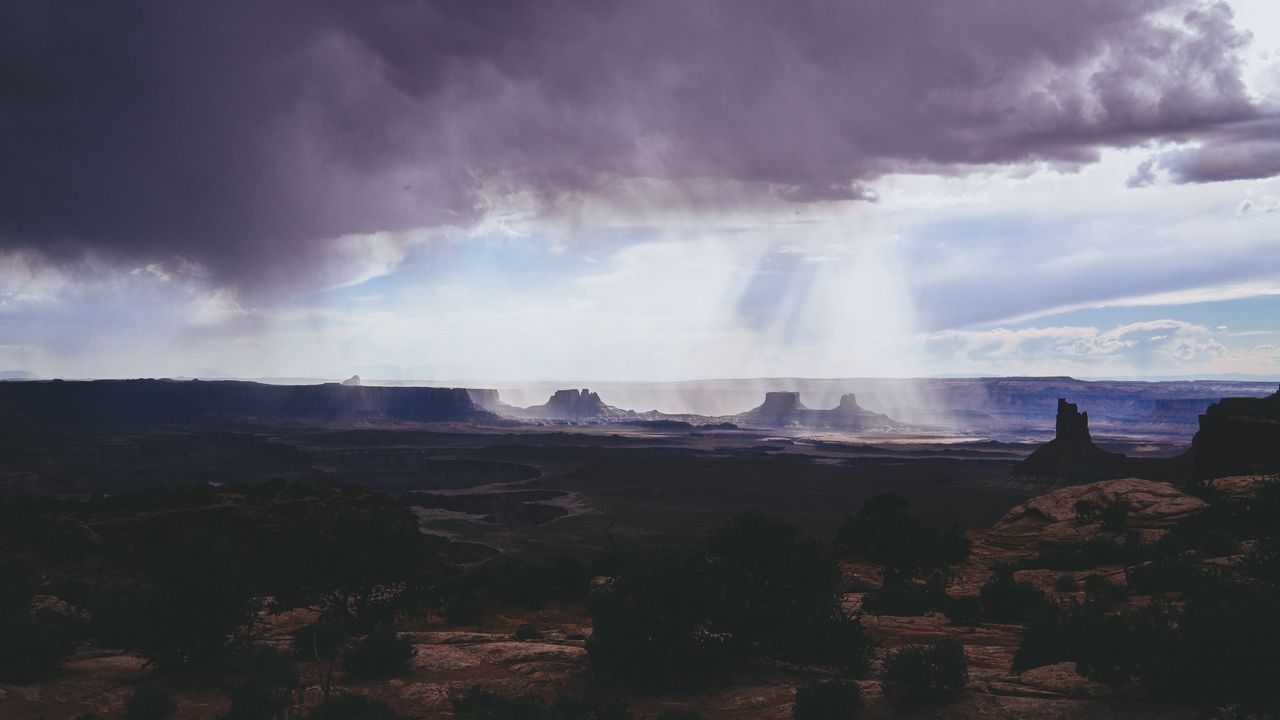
[1012,397,1125,487]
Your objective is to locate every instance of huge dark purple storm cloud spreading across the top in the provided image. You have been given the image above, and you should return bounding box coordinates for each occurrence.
[0,0,1276,291]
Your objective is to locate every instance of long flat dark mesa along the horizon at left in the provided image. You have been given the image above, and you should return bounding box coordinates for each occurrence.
[0,379,502,428]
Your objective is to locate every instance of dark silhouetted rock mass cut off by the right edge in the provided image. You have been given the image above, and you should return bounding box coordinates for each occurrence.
[1192,391,1280,480]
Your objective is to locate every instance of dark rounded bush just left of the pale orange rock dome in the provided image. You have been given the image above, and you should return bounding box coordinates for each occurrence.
[835,493,970,579]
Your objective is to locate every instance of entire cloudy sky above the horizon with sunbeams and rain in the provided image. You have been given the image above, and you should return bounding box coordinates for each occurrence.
[0,0,1280,380]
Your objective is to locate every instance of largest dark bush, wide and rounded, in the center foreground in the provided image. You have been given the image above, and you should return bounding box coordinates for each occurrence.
[588,515,869,687]
